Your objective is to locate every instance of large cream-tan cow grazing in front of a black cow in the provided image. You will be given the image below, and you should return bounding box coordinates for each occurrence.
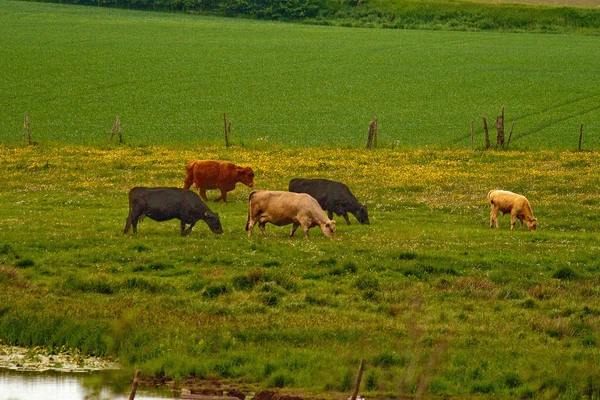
[246,190,335,239]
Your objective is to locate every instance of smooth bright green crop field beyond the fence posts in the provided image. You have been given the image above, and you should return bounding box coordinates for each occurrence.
[0,1,600,149]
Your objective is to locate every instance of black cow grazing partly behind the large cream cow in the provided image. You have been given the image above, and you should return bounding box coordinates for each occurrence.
[289,178,369,225]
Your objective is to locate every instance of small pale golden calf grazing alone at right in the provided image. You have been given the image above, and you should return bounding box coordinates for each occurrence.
[487,190,537,231]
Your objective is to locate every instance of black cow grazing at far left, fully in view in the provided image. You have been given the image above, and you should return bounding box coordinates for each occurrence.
[123,187,223,236]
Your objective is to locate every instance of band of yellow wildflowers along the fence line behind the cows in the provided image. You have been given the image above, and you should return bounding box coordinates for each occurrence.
[0,145,600,206]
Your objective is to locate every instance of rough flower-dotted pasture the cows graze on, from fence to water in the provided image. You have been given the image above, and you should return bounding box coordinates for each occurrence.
[0,145,600,399]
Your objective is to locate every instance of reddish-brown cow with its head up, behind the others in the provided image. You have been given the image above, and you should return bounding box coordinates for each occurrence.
[183,160,254,203]
